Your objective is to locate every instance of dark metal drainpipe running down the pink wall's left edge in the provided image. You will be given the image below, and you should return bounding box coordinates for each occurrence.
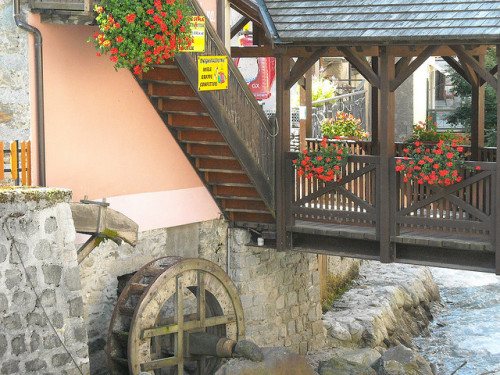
[12,0,47,186]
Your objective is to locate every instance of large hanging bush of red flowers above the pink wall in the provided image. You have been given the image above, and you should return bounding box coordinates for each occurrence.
[88,0,192,74]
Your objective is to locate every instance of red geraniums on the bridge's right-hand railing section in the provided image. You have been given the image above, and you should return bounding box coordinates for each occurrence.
[396,138,481,186]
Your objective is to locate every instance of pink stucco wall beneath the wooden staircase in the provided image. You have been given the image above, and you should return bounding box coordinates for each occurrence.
[29,14,218,229]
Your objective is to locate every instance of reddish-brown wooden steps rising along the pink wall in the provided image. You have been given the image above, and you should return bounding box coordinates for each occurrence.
[139,61,274,224]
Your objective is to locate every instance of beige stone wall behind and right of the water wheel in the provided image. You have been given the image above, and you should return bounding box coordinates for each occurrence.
[80,220,325,374]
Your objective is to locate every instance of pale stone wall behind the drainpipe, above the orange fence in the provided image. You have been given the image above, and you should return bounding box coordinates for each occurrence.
[0,0,31,142]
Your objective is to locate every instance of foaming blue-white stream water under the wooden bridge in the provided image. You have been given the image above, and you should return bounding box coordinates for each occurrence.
[415,268,500,375]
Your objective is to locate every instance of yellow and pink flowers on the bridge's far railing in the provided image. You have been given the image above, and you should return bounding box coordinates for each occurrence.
[321,111,369,140]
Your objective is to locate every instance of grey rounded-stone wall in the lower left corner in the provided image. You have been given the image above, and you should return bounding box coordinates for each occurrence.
[0,189,89,375]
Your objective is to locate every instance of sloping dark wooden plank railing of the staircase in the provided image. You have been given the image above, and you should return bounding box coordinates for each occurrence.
[175,1,276,212]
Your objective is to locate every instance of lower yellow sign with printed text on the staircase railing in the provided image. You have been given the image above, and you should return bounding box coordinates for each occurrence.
[198,56,228,91]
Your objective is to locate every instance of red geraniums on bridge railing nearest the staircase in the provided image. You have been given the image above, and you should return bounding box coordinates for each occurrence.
[293,137,350,182]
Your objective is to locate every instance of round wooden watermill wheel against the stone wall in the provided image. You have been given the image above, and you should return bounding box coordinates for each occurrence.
[106,257,244,375]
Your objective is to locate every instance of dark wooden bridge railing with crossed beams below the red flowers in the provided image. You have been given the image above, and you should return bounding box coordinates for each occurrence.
[287,140,497,250]
